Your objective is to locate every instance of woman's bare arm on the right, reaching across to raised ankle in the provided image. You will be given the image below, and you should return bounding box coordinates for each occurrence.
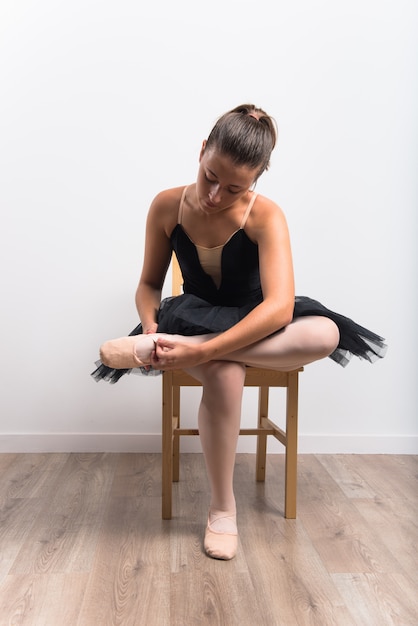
[152,196,295,369]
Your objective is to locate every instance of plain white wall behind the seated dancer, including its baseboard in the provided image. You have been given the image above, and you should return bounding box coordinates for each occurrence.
[0,0,418,452]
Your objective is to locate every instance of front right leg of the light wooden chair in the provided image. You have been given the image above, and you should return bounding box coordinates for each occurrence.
[284,372,298,519]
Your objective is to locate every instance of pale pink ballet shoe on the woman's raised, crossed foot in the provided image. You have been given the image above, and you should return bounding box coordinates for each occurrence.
[100,335,156,370]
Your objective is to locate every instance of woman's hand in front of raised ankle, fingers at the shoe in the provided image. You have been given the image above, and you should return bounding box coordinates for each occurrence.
[151,337,205,370]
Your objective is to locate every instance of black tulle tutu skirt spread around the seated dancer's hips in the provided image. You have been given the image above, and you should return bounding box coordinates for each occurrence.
[91,294,387,383]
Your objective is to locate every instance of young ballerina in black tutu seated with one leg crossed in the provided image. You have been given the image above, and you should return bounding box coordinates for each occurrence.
[93,104,385,559]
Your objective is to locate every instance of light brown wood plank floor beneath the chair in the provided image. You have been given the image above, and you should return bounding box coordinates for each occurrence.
[0,454,418,626]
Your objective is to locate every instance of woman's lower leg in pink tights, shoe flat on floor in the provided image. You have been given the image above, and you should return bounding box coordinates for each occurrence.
[188,361,245,559]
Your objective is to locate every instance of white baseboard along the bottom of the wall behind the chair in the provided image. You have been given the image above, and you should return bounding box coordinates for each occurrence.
[0,433,418,454]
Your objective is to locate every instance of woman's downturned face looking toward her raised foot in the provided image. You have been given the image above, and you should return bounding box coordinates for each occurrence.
[196,142,258,214]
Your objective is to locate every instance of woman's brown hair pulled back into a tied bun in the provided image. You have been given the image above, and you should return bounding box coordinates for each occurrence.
[205,104,277,178]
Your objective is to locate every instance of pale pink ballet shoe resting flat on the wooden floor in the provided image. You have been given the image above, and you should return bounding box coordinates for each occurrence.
[204,515,238,561]
